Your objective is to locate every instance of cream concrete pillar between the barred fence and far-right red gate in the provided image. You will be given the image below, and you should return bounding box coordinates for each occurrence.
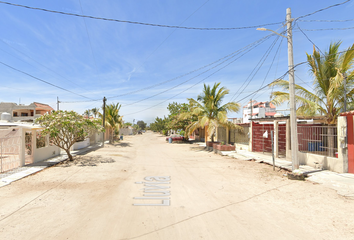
[337,116,348,173]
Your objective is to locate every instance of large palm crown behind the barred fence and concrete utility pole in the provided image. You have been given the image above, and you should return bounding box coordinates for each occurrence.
[271,42,354,124]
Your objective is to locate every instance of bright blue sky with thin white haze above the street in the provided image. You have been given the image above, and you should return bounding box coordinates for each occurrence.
[0,0,354,123]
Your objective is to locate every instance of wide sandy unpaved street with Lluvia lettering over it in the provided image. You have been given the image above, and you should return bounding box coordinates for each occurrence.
[0,132,354,240]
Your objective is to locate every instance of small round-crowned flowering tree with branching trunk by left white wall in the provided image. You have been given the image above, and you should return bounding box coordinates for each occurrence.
[36,111,103,161]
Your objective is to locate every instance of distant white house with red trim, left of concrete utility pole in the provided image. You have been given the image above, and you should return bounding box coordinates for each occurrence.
[242,100,277,123]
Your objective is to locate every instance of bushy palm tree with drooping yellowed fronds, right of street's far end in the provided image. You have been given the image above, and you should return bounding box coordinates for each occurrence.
[181,83,240,142]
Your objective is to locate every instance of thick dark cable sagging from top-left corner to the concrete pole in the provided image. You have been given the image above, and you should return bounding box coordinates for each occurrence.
[0,1,282,30]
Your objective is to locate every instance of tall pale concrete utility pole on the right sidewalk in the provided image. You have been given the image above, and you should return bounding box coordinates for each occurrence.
[286,8,299,171]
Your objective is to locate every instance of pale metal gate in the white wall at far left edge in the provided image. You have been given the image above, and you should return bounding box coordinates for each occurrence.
[0,129,21,172]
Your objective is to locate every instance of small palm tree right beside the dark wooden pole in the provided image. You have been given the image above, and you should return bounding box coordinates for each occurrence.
[98,103,123,143]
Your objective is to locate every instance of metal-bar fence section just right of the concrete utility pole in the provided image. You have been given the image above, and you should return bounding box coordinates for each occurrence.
[297,124,338,157]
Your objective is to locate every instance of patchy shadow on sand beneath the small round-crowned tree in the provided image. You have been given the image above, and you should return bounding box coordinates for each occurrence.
[57,155,115,167]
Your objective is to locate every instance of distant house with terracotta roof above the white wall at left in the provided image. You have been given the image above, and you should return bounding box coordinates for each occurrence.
[0,102,54,122]
